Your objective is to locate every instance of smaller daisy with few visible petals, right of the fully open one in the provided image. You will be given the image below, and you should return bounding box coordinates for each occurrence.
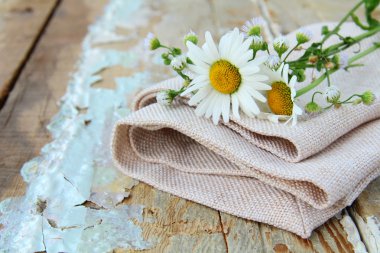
[260,64,302,126]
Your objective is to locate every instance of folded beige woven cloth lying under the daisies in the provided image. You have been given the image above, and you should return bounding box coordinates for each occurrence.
[113,22,380,237]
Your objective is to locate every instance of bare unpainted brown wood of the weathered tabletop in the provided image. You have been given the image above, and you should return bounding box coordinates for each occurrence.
[0,0,380,252]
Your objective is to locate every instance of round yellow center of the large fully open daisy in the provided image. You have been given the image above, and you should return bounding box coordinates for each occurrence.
[210,60,241,94]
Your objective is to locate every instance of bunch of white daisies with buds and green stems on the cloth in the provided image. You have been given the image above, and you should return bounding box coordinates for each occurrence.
[145,0,380,125]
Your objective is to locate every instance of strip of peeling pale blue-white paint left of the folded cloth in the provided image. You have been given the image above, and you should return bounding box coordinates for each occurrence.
[0,0,167,253]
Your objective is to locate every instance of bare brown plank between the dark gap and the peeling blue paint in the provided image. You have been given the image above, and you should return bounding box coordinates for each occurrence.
[0,0,106,200]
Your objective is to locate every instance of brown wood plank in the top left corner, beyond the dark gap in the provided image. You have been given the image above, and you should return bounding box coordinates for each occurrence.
[0,0,59,108]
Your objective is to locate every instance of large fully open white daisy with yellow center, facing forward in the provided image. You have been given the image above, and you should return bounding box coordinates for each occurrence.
[182,28,271,124]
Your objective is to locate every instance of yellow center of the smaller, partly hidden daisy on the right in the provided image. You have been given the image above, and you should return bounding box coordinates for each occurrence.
[267,82,293,116]
